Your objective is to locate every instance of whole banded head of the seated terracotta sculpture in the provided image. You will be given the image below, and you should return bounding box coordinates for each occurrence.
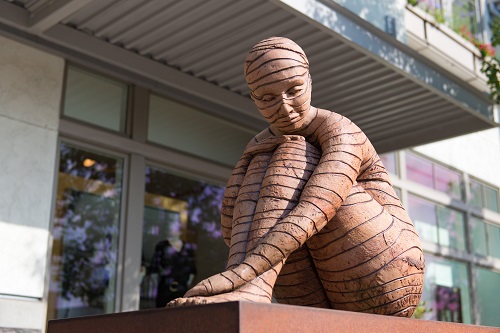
[245,37,311,134]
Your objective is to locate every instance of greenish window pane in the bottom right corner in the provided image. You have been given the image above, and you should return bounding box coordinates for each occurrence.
[476,267,500,327]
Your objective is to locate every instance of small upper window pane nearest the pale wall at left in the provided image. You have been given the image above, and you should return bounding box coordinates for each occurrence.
[63,66,127,132]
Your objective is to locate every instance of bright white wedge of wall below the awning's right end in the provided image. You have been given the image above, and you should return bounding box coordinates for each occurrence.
[415,128,500,187]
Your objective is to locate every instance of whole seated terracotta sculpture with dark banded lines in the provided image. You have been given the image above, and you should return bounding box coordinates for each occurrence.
[169,37,425,317]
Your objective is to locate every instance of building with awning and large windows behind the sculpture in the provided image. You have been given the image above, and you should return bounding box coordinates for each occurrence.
[0,0,500,332]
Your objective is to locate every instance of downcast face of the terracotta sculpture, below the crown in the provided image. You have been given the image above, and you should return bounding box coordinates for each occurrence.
[247,57,311,134]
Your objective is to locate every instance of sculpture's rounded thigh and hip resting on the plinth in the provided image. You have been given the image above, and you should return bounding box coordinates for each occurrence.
[307,185,424,316]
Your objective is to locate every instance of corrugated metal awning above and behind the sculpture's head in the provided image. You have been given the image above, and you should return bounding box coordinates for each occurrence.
[0,0,498,152]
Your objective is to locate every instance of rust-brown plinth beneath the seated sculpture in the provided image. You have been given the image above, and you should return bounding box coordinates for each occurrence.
[48,302,500,333]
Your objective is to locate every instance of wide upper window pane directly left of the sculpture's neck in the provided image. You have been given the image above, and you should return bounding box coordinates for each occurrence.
[148,95,256,166]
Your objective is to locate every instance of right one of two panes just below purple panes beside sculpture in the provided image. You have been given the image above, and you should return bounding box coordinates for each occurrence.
[436,206,466,251]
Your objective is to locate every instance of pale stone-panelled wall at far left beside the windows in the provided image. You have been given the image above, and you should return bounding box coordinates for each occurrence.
[0,36,64,330]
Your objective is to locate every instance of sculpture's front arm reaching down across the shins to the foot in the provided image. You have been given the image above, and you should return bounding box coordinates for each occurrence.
[186,120,372,297]
